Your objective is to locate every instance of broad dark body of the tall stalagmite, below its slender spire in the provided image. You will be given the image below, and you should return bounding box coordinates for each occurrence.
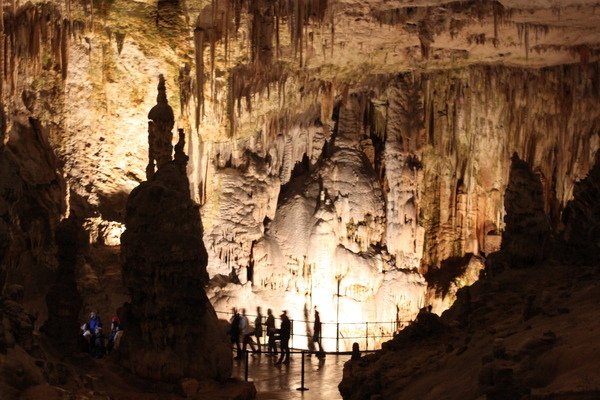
[121,78,231,381]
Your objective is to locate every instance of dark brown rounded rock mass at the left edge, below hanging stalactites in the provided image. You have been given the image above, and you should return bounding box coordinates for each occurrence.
[0,118,66,322]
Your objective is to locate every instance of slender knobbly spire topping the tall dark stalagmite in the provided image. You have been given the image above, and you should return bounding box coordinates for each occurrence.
[146,75,175,179]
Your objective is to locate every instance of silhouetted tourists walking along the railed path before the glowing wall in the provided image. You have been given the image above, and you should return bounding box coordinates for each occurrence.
[229,307,325,365]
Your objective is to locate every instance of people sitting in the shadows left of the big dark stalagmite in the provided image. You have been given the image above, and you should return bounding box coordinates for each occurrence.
[81,311,123,358]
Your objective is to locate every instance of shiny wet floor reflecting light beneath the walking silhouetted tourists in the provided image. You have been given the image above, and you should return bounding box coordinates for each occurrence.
[233,354,350,400]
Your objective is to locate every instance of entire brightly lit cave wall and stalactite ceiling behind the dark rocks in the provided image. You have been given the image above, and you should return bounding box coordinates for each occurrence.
[0,0,600,354]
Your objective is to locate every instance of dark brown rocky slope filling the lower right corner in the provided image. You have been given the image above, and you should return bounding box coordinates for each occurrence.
[339,262,600,400]
